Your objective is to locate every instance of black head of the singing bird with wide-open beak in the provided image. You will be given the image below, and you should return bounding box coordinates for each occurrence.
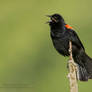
[47,14,64,25]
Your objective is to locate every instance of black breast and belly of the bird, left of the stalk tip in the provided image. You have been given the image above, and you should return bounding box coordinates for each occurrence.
[51,34,69,56]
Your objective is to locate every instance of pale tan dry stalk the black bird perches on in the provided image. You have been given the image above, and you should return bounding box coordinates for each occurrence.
[68,41,78,92]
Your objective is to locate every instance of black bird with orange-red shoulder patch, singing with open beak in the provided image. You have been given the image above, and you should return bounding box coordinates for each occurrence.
[48,14,92,81]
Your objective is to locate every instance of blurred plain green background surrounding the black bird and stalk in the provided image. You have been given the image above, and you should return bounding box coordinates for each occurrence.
[0,0,92,92]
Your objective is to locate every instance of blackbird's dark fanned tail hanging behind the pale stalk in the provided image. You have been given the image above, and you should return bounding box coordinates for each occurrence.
[73,51,92,81]
